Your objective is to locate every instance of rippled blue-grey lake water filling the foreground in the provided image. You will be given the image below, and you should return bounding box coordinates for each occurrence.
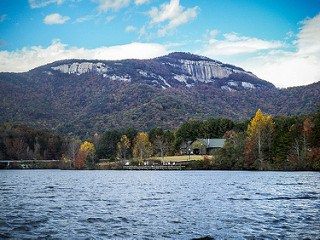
[0,170,320,239]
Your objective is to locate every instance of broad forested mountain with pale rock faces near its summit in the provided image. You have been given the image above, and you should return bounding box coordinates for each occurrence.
[0,52,320,135]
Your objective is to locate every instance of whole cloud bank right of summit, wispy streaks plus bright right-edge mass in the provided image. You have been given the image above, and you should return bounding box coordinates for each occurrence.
[200,14,320,88]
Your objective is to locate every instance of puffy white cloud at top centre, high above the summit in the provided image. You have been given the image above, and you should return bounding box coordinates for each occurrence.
[148,0,199,36]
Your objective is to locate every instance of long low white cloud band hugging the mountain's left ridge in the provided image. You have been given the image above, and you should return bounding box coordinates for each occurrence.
[0,40,168,72]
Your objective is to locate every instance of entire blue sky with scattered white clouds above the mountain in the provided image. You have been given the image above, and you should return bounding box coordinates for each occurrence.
[0,0,320,88]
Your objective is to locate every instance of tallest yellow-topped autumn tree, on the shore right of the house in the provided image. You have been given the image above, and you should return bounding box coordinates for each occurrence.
[245,109,273,169]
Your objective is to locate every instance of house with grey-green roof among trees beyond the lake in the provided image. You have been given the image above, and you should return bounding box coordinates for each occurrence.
[180,138,226,155]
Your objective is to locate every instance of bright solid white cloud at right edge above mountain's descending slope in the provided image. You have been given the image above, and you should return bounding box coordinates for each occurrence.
[243,14,320,87]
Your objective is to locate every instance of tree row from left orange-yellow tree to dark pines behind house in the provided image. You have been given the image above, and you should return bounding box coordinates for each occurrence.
[64,119,235,169]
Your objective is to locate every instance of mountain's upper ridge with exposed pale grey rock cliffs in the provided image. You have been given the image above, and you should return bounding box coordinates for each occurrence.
[43,52,274,91]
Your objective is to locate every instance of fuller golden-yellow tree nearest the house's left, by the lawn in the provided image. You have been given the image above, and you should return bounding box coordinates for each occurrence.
[133,132,151,160]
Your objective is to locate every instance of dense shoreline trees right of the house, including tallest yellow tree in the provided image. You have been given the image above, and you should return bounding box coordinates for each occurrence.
[215,108,320,171]
